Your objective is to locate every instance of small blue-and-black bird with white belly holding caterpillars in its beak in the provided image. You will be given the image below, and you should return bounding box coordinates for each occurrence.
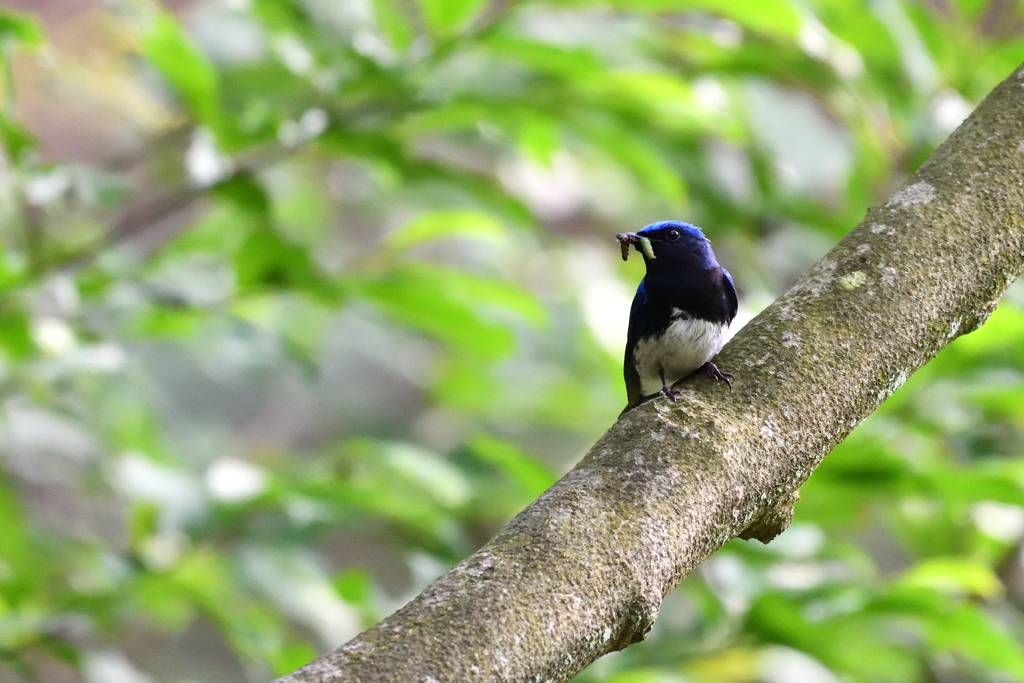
[616,220,738,414]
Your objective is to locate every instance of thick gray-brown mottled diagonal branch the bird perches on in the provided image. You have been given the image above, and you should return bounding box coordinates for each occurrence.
[280,67,1024,683]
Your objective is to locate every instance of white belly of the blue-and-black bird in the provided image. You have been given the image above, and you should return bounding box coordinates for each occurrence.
[633,317,729,396]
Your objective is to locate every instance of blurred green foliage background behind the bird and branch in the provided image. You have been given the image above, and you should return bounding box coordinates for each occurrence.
[0,0,1024,683]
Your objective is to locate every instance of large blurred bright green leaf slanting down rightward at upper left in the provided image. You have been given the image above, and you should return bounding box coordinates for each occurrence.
[142,11,221,131]
